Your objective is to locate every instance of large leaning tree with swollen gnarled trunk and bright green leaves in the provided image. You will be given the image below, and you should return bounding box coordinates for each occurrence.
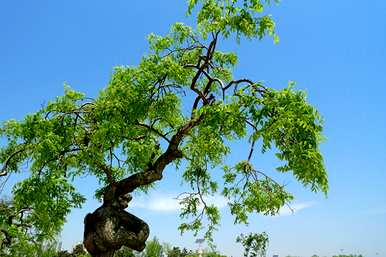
[0,0,328,257]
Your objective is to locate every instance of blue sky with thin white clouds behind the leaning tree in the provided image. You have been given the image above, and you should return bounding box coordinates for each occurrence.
[0,0,386,257]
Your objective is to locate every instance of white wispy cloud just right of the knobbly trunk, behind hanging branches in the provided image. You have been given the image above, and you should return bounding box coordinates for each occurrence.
[130,194,227,212]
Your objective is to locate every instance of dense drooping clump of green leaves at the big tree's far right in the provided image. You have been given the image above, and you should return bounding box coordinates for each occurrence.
[255,87,328,193]
